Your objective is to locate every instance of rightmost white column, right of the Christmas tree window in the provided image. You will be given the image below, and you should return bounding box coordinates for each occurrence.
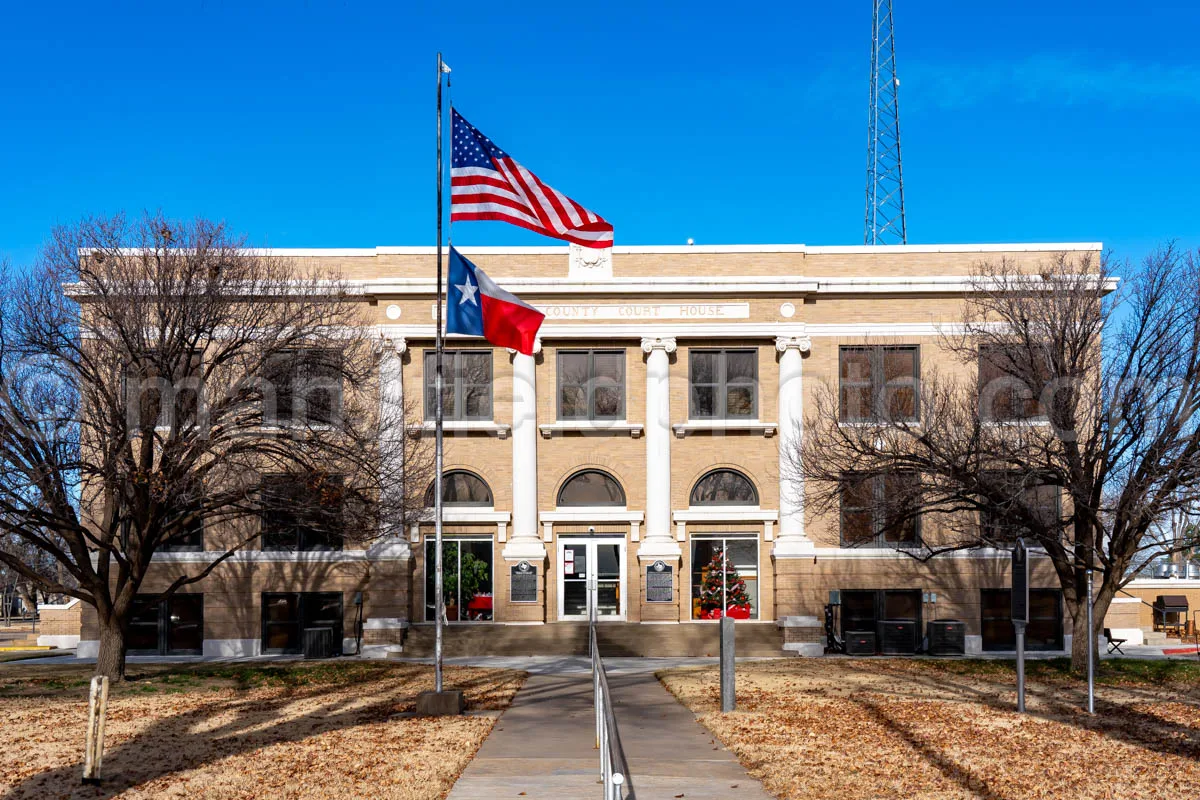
[772,336,815,558]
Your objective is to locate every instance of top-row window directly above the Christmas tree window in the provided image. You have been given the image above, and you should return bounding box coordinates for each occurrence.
[688,349,758,420]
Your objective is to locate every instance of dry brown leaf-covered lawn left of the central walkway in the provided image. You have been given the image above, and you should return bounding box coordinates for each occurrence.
[0,662,524,800]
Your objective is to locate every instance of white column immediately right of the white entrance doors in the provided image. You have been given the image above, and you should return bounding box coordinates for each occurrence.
[637,337,682,560]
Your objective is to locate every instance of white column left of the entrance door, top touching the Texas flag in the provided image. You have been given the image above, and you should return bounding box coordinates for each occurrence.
[504,339,546,561]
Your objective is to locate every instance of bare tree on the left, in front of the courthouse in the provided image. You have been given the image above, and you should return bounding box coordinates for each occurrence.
[0,215,432,679]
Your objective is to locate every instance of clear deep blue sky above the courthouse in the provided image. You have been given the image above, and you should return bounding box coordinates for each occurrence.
[0,0,1200,263]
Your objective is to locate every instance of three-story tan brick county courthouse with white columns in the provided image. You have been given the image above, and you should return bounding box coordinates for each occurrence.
[72,243,1100,655]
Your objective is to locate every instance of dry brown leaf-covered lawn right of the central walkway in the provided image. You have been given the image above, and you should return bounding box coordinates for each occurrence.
[659,658,1200,800]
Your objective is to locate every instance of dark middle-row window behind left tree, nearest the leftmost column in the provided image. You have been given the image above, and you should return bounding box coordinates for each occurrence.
[259,475,343,552]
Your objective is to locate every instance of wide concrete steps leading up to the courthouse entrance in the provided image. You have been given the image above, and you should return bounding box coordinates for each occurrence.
[403,622,787,658]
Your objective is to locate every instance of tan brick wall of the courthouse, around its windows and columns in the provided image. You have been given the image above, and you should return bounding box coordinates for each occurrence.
[84,245,1098,652]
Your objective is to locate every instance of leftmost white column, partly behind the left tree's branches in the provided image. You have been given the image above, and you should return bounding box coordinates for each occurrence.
[367,337,412,558]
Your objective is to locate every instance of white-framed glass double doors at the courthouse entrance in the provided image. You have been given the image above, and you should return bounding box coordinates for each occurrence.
[558,537,625,620]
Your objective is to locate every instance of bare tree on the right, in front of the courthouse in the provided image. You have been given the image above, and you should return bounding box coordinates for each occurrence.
[790,246,1200,669]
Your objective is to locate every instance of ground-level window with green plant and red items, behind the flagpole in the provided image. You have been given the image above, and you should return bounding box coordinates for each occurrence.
[425,537,492,622]
